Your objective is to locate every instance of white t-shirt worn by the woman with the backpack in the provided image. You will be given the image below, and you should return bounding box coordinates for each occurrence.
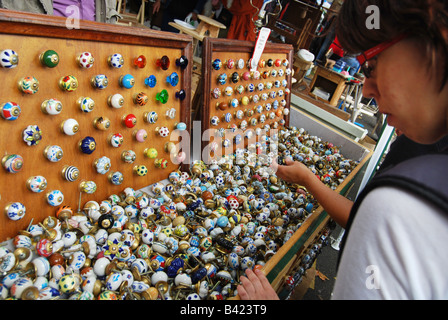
[333,187,448,300]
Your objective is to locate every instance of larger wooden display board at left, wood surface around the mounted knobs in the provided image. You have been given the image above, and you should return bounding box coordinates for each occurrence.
[0,10,192,241]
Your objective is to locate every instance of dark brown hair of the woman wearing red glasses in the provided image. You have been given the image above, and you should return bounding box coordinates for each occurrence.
[336,0,448,87]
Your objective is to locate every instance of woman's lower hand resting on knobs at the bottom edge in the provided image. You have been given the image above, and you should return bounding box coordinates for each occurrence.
[237,269,280,300]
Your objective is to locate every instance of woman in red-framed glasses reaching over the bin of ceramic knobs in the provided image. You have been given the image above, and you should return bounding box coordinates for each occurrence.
[238,0,448,299]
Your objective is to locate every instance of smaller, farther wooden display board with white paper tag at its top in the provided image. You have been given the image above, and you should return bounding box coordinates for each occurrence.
[200,38,293,160]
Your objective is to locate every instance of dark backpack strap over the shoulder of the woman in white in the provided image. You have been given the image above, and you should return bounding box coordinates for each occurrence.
[339,153,448,266]
